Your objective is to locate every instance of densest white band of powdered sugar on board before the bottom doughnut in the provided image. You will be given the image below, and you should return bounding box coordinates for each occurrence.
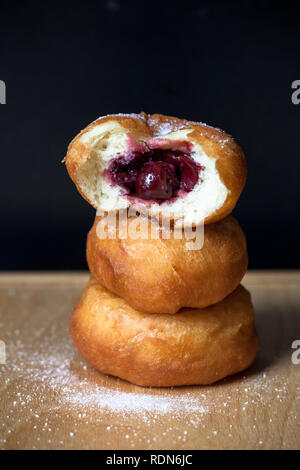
[2,338,207,419]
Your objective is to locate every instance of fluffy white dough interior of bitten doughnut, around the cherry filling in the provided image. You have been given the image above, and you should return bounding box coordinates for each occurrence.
[77,126,228,224]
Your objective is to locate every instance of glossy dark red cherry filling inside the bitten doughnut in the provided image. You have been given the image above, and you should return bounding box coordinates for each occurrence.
[108,149,201,201]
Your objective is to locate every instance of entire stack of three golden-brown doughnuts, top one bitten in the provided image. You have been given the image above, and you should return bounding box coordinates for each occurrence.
[64,113,258,387]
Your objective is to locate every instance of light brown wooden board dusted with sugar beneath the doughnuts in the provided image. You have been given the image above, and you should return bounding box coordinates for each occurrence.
[0,272,300,449]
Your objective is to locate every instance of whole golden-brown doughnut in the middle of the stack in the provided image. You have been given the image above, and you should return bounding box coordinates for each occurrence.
[87,216,248,314]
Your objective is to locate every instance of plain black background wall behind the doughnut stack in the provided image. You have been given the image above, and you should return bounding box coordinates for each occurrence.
[0,0,300,270]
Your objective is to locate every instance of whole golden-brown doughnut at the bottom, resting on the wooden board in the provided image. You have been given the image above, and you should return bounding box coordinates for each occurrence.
[70,280,258,387]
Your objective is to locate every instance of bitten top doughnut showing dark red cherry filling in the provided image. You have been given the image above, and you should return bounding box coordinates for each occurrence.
[64,113,246,225]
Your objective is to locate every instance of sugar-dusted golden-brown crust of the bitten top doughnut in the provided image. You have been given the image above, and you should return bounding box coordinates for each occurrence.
[63,112,247,224]
